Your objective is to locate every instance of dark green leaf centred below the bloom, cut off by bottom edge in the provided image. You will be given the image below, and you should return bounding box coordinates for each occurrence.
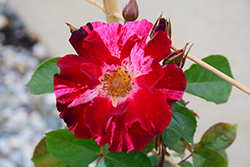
[104,151,153,167]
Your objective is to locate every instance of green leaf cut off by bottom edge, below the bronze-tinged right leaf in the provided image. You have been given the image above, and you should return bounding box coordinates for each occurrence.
[193,147,228,167]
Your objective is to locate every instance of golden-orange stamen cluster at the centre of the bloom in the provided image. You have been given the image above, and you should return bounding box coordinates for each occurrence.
[100,67,133,99]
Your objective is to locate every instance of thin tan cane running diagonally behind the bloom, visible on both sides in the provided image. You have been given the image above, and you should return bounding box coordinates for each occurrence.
[87,0,250,95]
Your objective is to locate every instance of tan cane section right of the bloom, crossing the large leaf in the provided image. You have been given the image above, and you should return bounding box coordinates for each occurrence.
[171,44,250,95]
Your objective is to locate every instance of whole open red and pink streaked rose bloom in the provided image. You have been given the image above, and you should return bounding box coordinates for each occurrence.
[54,20,186,152]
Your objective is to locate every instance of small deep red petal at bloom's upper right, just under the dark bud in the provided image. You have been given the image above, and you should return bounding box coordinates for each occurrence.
[144,31,172,62]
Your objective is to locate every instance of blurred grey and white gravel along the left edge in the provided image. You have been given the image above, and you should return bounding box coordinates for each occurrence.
[0,0,64,167]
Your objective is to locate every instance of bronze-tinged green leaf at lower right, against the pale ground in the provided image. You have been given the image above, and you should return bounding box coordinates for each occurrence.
[199,123,237,151]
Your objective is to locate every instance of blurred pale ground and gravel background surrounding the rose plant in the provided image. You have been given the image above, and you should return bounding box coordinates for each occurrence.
[0,0,250,167]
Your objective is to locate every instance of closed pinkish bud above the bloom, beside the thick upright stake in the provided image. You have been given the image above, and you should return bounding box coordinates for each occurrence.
[122,0,139,22]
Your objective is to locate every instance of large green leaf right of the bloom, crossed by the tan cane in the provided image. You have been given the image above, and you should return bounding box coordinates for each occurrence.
[184,55,233,104]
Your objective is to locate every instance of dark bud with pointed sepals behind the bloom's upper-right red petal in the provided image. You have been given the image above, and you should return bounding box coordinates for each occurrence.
[150,13,171,39]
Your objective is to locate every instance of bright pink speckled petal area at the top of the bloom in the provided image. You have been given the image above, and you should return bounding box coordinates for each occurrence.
[95,19,152,60]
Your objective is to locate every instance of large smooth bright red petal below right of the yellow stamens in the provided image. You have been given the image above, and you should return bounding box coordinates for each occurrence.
[126,89,172,135]
